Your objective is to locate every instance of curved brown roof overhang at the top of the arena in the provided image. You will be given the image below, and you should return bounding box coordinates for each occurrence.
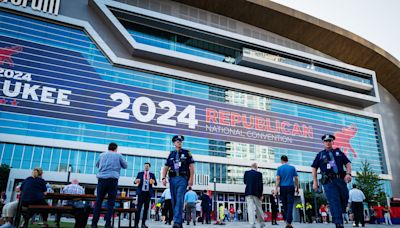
[174,0,400,102]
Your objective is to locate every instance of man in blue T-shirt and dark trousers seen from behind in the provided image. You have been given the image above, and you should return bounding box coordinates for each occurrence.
[276,155,299,228]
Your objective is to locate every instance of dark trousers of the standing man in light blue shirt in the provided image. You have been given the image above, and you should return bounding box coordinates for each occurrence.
[92,178,118,227]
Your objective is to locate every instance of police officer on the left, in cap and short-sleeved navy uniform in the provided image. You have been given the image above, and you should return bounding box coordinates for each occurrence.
[161,135,194,228]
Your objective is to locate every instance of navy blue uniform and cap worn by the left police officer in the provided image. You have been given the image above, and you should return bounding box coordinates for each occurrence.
[165,136,194,226]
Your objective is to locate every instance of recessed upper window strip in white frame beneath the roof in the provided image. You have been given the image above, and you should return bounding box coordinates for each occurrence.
[119,18,372,85]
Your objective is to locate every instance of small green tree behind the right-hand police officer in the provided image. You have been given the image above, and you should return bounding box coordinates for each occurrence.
[355,160,386,205]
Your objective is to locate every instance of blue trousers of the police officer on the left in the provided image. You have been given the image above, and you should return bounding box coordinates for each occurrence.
[169,176,188,224]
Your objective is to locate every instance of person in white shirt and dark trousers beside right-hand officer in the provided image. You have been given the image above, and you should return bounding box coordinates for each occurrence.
[349,184,365,227]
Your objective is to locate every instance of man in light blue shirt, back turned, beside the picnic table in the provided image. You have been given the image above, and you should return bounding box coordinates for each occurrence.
[92,143,128,228]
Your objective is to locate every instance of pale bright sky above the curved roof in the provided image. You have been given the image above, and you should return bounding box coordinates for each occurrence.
[273,0,400,61]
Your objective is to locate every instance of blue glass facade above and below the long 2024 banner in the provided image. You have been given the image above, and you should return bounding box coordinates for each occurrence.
[0,11,387,194]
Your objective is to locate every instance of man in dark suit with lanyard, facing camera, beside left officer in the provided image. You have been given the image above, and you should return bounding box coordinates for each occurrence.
[135,162,157,228]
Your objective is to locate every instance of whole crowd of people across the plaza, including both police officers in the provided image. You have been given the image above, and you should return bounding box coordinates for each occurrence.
[1,134,391,228]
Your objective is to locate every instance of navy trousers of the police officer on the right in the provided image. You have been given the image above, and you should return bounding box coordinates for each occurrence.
[323,178,349,224]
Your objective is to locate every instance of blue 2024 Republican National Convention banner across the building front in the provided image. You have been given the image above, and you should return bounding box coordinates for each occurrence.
[0,36,357,154]
